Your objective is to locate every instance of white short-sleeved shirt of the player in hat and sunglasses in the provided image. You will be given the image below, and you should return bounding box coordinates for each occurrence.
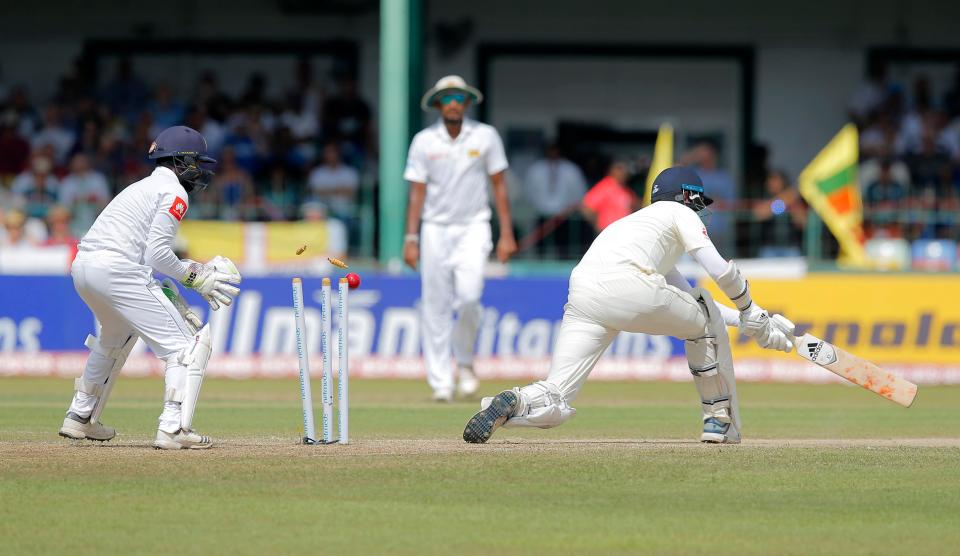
[403,118,508,224]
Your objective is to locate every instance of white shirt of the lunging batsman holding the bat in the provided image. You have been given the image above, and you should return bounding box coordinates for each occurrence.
[574,201,713,276]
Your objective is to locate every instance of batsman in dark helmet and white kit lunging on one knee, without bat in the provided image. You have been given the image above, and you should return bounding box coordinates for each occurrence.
[463,167,793,443]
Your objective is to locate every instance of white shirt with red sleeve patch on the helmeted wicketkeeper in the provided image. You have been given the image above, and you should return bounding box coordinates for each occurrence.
[79,166,189,280]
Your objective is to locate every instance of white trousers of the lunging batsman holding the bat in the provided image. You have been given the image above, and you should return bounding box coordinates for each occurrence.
[546,267,707,401]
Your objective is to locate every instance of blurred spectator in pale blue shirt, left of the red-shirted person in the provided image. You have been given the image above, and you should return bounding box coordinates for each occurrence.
[523,143,588,257]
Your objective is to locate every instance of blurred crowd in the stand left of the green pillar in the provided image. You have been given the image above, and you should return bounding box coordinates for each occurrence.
[0,54,376,250]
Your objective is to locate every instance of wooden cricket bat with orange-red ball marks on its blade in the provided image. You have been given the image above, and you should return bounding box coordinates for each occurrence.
[784,315,917,407]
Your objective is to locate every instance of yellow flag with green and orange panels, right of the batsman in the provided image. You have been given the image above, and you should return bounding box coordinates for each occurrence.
[799,124,867,266]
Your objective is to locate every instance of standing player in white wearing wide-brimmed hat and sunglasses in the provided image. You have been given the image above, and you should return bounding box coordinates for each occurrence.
[403,75,517,402]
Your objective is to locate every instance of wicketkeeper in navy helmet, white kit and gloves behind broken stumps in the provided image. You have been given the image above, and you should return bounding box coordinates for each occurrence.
[60,126,240,450]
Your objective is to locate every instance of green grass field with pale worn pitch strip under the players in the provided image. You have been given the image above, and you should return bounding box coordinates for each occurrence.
[0,379,960,555]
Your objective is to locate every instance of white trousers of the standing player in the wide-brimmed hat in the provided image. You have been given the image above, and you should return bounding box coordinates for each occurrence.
[420,221,493,391]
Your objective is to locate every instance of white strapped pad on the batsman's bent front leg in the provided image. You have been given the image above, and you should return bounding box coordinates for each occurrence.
[684,288,740,431]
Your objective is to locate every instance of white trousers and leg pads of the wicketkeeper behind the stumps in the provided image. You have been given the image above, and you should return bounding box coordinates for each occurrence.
[70,251,193,433]
